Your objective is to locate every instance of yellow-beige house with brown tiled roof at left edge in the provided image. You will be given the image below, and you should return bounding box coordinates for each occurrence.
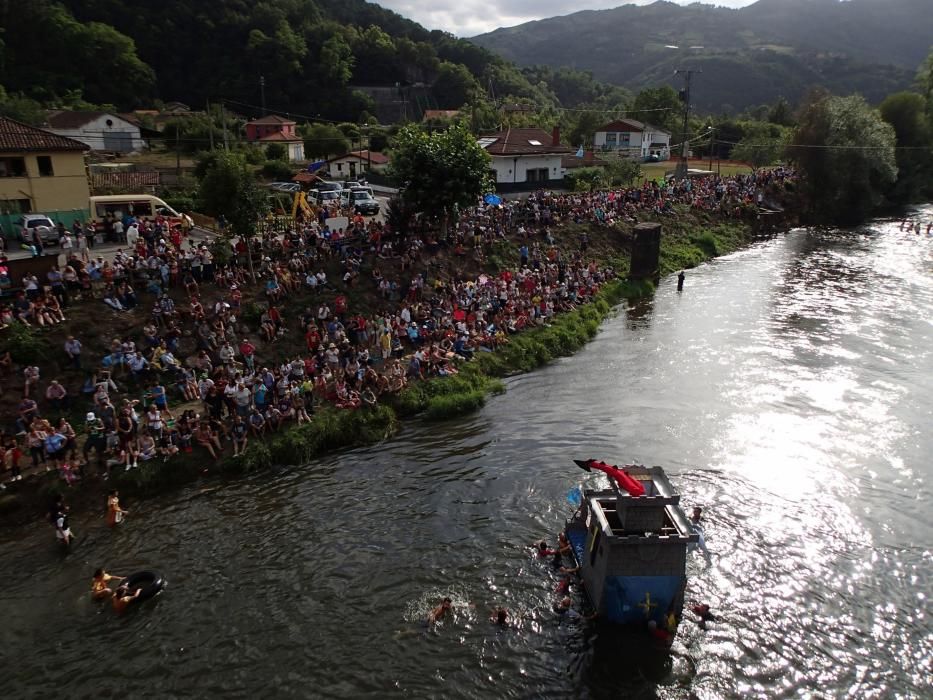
[0,117,90,236]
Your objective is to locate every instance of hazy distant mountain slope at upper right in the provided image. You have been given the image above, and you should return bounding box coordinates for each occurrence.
[472,0,933,112]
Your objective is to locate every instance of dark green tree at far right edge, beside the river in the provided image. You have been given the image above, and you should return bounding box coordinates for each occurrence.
[878,92,933,203]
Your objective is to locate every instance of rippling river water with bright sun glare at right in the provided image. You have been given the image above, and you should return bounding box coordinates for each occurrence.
[0,208,933,698]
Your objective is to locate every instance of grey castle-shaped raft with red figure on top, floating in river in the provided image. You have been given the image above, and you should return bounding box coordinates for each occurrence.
[564,460,699,643]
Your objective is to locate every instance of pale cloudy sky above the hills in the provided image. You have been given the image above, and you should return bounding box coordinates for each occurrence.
[371,0,755,36]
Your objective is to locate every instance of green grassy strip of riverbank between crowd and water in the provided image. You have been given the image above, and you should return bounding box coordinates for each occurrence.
[0,208,788,524]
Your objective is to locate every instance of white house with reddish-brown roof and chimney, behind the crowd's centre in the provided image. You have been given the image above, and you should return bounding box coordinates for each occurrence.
[477,128,574,189]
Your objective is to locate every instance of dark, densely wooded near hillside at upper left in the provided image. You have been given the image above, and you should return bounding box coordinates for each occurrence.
[0,0,626,120]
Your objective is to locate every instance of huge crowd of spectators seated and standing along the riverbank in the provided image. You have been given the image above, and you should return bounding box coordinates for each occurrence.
[0,170,792,484]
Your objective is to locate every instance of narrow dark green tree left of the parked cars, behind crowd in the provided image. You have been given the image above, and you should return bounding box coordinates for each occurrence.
[198,153,269,279]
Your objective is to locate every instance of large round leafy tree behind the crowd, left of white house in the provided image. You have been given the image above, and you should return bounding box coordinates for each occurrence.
[390,124,491,236]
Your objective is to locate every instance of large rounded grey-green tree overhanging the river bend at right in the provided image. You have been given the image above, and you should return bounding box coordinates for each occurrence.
[787,92,897,224]
